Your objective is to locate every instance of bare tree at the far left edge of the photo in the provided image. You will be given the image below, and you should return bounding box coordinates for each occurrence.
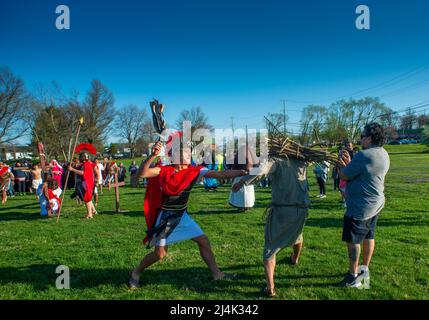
[0,67,29,143]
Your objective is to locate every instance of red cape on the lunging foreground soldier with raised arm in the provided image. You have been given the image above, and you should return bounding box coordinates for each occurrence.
[143,166,203,243]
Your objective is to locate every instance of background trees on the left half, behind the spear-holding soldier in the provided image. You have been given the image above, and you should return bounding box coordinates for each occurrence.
[0,67,213,160]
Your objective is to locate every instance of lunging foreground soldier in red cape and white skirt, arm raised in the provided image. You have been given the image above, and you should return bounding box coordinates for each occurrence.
[129,134,246,290]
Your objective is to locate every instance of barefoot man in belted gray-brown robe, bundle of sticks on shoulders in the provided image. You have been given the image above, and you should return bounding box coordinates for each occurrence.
[233,158,310,297]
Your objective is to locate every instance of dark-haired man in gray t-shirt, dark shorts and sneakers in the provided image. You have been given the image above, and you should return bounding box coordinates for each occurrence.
[339,123,390,288]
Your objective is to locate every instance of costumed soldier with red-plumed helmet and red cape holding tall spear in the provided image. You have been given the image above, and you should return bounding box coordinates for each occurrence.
[69,152,99,219]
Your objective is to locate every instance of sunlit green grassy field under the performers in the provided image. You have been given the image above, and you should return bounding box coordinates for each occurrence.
[0,145,429,299]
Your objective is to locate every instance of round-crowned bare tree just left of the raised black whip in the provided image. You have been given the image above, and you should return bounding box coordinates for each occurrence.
[115,105,153,158]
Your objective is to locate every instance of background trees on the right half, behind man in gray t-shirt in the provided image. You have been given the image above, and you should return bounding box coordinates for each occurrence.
[265,97,429,145]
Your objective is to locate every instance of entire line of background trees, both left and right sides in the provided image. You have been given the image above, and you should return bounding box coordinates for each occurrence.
[0,67,429,160]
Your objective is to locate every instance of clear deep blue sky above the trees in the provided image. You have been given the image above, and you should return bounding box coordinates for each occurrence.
[0,0,429,142]
